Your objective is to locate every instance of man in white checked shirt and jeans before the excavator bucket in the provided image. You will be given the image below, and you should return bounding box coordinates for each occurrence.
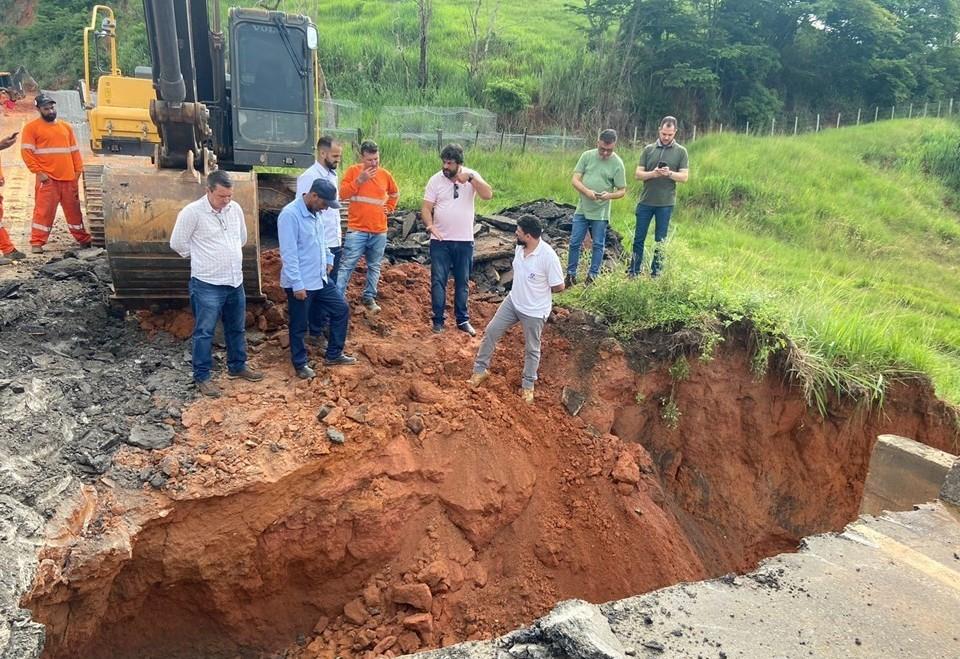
[170,170,263,398]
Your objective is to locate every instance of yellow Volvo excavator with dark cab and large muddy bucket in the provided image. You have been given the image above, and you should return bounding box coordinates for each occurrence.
[81,0,318,308]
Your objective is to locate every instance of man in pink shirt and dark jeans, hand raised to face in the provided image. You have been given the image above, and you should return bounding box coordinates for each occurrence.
[420,144,493,336]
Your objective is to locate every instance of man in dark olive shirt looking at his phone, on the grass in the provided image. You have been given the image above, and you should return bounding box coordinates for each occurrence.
[628,116,689,277]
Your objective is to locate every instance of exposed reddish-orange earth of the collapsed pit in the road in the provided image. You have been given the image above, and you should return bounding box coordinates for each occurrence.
[18,264,953,658]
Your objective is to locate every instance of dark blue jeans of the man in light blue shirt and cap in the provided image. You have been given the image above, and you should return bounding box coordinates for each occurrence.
[284,284,350,368]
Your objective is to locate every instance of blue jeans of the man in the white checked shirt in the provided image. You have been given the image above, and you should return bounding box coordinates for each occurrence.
[189,277,247,382]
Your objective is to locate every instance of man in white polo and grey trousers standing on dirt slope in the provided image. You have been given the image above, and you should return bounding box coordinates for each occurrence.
[470,215,564,403]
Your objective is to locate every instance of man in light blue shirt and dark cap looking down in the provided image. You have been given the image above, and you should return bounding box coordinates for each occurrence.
[277,179,357,380]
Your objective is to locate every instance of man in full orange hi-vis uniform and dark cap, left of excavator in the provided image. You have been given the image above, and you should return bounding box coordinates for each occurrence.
[20,94,91,254]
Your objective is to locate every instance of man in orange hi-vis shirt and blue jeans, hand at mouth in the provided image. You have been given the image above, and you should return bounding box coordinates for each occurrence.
[337,140,400,314]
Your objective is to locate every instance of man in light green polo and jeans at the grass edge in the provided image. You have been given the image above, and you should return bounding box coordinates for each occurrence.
[564,128,627,287]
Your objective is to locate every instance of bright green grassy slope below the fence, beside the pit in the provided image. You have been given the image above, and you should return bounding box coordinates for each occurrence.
[370,120,960,408]
